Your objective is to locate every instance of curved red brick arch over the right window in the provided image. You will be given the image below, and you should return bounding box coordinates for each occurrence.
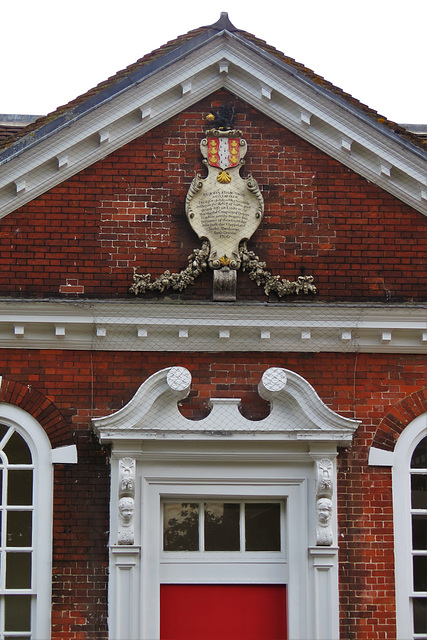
[372,387,427,451]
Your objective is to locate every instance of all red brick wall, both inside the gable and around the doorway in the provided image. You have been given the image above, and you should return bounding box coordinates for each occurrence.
[0,92,427,640]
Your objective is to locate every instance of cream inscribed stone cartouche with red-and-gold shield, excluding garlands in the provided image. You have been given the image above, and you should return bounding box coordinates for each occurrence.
[185,130,264,269]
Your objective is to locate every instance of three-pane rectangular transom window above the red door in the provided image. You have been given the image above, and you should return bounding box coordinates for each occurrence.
[163,500,284,552]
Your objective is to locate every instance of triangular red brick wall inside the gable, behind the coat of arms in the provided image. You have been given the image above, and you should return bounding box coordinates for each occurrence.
[0,92,427,301]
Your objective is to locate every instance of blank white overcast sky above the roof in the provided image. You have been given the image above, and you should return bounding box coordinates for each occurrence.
[0,0,427,124]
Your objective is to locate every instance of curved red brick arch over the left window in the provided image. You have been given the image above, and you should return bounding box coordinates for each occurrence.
[0,378,73,449]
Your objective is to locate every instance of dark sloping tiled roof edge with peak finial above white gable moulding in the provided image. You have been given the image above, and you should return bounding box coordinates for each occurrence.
[0,12,426,158]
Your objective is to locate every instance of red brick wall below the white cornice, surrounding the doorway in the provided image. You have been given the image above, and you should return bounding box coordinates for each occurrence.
[1,349,427,640]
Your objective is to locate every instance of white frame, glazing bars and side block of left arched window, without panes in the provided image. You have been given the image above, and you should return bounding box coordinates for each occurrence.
[0,403,77,640]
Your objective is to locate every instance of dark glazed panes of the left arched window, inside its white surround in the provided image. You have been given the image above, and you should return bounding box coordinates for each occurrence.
[0,425,35,640]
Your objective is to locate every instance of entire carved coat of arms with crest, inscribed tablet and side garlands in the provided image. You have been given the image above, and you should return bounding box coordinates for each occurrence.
[130,105,316,300]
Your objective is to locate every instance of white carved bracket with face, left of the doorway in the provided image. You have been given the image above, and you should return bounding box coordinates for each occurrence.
[118,458,135,544]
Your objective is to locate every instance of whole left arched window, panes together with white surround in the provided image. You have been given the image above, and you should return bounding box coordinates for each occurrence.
[0,404,52,640]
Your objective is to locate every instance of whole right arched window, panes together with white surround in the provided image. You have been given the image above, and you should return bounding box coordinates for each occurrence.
[393,414,427,640]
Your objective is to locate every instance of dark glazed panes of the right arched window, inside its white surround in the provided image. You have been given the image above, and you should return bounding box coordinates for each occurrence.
[410,436,427,638]
